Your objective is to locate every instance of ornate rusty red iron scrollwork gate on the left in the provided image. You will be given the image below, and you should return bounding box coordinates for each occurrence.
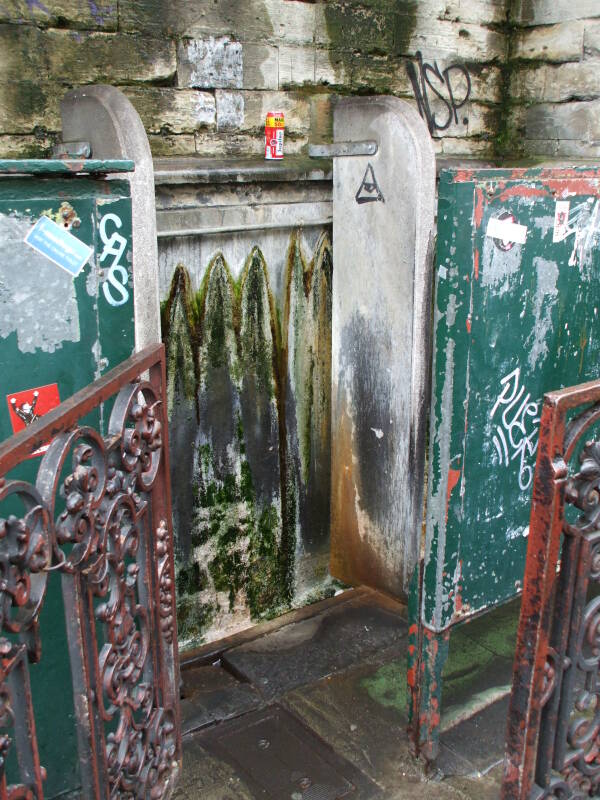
[0,345,181,800]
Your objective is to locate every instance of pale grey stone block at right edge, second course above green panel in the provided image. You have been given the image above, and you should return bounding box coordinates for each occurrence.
[525,100,600,143]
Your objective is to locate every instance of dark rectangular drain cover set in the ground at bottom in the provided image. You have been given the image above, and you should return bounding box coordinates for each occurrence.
[199,706,376,800]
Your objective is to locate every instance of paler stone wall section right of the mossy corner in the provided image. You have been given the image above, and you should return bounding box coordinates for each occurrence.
[505,0,600,158]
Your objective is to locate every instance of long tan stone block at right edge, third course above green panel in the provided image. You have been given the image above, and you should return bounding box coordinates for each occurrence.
[510,60,600,103]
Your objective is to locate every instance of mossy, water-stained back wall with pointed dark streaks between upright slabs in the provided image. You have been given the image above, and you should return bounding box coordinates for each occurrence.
[162,234,334,648]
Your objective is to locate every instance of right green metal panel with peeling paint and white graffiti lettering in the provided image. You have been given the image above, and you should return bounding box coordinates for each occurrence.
[422,167,600,631]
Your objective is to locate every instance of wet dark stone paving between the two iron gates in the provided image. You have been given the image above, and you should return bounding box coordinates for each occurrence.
[175,594,518,800]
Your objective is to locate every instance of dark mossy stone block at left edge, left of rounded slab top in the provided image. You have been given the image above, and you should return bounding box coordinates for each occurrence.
[0,81,64,134]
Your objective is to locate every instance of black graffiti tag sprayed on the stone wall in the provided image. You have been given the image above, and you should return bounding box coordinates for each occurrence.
[406,51,471,136]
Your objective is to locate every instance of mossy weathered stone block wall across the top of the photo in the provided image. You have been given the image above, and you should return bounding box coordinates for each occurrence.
[0,0,600,162]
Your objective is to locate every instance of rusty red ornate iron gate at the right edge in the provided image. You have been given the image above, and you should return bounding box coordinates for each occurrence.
[502,381,600,800]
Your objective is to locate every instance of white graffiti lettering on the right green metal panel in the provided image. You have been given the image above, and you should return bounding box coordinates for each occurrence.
[490,367,540,491]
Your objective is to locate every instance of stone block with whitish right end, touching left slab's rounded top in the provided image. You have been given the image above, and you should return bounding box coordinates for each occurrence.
[125,86,216,134]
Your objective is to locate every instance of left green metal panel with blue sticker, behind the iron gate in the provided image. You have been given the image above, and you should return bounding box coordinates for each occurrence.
[0,170,134,797]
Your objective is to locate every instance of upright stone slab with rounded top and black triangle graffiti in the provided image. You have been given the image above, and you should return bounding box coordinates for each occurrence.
[331,97,435,596]
